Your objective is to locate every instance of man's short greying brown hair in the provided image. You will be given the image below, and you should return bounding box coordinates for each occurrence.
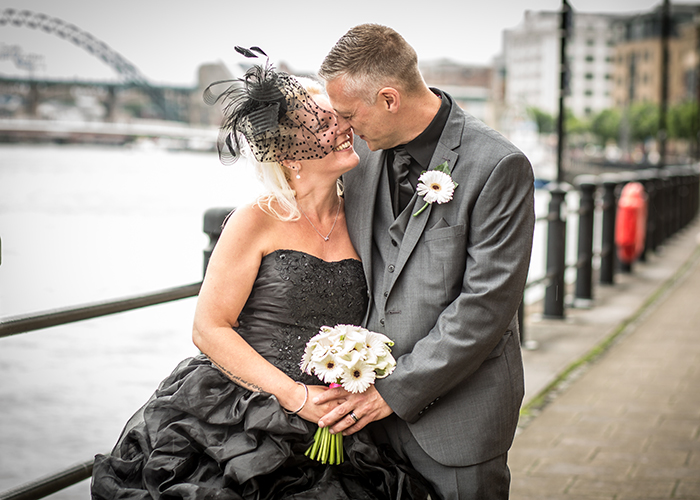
[318,24,425,105]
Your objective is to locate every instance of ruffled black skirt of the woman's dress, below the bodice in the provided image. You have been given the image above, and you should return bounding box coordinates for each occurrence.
[92,356,434,500]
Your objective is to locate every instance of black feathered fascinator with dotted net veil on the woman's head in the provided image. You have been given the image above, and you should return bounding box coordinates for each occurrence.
[204,47,337,164]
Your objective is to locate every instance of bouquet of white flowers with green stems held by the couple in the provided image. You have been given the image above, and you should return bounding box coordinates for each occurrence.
[301,325,396,464]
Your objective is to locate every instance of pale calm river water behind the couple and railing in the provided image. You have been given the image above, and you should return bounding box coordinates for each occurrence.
[0,145,547,500]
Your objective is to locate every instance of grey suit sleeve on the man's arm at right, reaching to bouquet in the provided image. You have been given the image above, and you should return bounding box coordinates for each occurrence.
[377,153,535,423]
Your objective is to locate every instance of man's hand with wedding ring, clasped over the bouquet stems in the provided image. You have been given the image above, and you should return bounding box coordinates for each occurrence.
[313,385,393,436]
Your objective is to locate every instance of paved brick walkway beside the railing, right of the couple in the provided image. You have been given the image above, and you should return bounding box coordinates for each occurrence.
[509,218,700,500]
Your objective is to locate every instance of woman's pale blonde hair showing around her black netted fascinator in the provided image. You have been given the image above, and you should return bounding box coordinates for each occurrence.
[241,76,342,222]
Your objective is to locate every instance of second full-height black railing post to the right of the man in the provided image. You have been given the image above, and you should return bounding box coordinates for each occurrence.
[574,175,598,307]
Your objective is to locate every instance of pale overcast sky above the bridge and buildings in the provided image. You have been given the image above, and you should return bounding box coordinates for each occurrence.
[0,0,698,85]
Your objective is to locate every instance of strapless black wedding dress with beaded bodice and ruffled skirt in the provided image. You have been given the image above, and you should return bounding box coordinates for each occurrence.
[92,250,429,500]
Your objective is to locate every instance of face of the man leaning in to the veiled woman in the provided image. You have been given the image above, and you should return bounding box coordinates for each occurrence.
[326,78,398,151]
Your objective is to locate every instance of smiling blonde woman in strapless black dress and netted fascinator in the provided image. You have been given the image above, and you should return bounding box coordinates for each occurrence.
[92,49,429,499]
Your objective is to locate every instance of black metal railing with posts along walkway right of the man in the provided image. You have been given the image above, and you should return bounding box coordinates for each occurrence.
[520,165,700,342]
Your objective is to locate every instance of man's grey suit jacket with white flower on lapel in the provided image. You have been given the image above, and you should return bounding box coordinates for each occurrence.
[344,95,534,466]
